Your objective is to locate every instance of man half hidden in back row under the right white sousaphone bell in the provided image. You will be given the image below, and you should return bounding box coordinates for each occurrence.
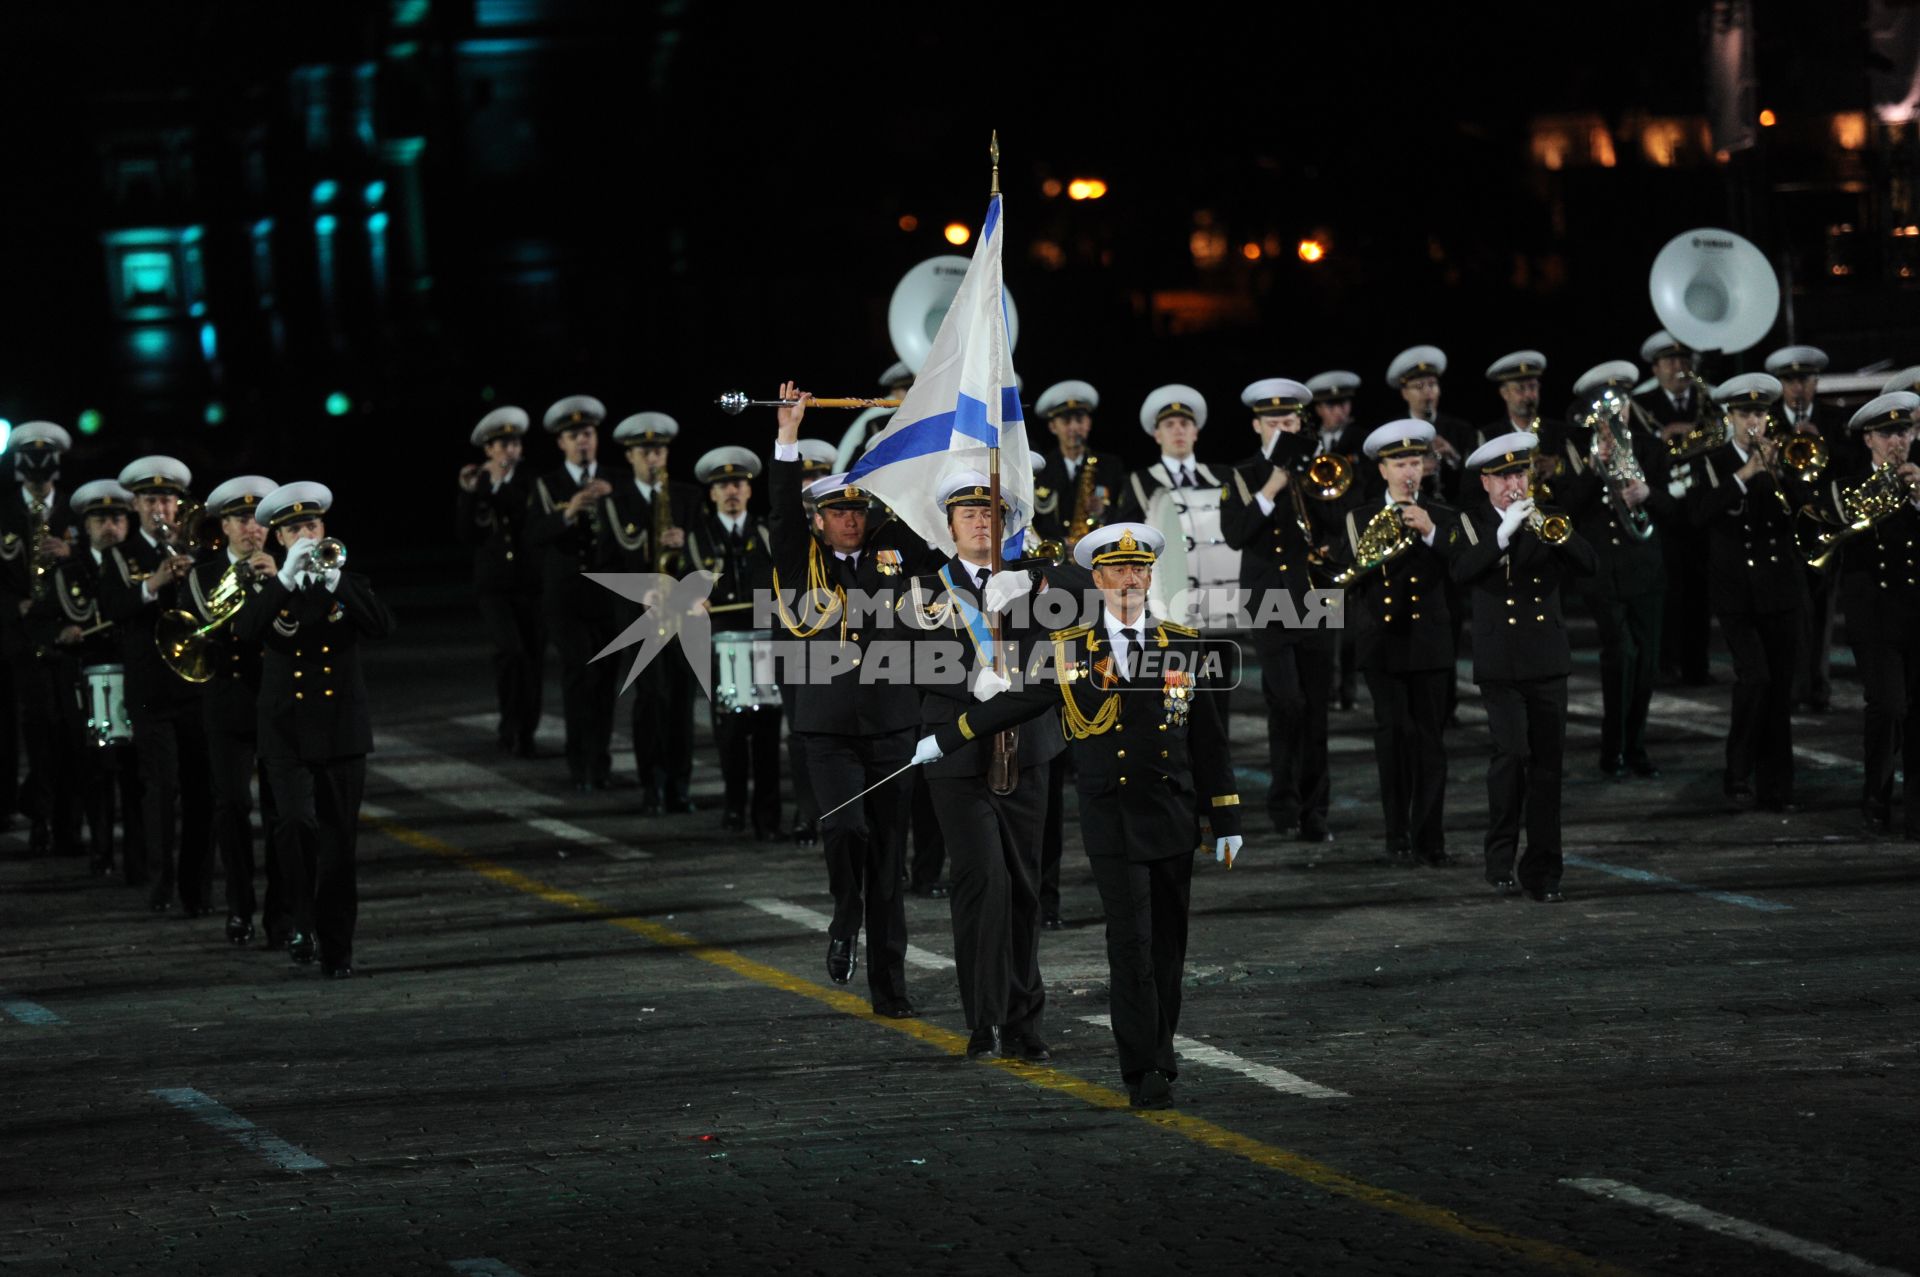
[1634,328,1715,687]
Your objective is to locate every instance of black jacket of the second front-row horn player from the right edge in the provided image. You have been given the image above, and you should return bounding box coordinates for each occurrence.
[1686,444,1816,616]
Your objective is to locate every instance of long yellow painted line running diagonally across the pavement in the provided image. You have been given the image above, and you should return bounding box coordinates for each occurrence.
[363,816,1630,1277]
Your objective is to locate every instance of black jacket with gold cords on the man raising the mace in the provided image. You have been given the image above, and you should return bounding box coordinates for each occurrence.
[768,461,941,735]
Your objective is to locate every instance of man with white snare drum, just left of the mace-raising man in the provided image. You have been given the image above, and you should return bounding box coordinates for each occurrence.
[691,447,781,843]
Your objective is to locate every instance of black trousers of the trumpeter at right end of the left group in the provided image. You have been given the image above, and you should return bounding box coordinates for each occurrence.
[267,755,367,966]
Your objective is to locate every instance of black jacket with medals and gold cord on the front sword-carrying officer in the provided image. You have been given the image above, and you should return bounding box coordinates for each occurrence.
[935,620,1240,860]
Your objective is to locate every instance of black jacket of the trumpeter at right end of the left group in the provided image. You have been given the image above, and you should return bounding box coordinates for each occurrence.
[230,572,394,762]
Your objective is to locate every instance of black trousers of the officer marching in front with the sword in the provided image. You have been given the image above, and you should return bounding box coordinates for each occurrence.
[1087,851,1194,1083]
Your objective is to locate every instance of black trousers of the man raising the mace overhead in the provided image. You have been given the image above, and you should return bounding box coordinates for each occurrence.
[799,728,918,1006]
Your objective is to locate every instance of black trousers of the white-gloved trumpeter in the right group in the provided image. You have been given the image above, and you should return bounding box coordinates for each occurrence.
[1480,676,1567,891]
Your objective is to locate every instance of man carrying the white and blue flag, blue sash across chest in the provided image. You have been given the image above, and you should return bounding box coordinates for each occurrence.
[902,470,1064,1062]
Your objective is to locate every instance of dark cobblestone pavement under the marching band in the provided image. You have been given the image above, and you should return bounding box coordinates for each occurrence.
[0,602,1920,1277]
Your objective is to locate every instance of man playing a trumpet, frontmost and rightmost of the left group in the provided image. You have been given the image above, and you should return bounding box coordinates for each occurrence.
[232,482,394,979]
